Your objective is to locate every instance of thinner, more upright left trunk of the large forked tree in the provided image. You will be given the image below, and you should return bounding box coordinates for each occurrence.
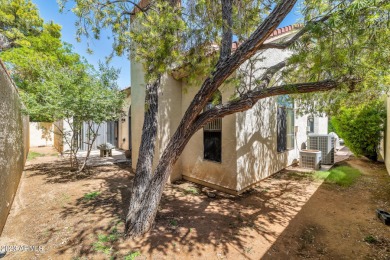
[126,76,160,232]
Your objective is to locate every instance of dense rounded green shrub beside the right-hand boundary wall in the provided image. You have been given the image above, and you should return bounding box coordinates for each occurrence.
[331,101,386,160]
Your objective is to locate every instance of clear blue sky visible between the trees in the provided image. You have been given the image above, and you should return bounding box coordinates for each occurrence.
[32,0,301,89]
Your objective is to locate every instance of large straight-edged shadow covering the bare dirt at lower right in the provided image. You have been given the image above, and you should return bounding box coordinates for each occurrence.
[262,157,390,259]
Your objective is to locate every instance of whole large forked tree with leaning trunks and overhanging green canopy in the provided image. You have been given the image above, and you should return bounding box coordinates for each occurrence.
[61,0,390,235]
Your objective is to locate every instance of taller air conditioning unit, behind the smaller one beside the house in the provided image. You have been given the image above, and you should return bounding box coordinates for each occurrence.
[309,135,334,164]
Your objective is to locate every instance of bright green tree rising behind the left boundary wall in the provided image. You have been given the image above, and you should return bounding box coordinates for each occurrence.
[0,0,82,122]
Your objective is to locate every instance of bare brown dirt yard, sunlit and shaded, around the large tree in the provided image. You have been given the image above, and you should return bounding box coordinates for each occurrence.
[0,148,390,260]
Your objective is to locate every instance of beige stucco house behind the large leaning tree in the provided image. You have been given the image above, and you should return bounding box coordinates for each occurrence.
[131,26,328,194]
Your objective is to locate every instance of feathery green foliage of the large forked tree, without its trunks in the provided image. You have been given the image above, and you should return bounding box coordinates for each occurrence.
[61,0,390,103]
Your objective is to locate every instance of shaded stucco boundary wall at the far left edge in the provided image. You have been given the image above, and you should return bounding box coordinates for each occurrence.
[0,61,29,234]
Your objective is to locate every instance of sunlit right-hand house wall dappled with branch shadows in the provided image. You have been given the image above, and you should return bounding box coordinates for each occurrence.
[236,97,328,192]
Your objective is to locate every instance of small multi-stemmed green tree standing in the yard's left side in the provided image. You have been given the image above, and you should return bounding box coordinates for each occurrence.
[45,65,124,172]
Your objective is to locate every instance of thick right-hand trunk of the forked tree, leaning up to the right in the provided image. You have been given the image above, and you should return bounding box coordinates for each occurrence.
[126,0,296,236]
